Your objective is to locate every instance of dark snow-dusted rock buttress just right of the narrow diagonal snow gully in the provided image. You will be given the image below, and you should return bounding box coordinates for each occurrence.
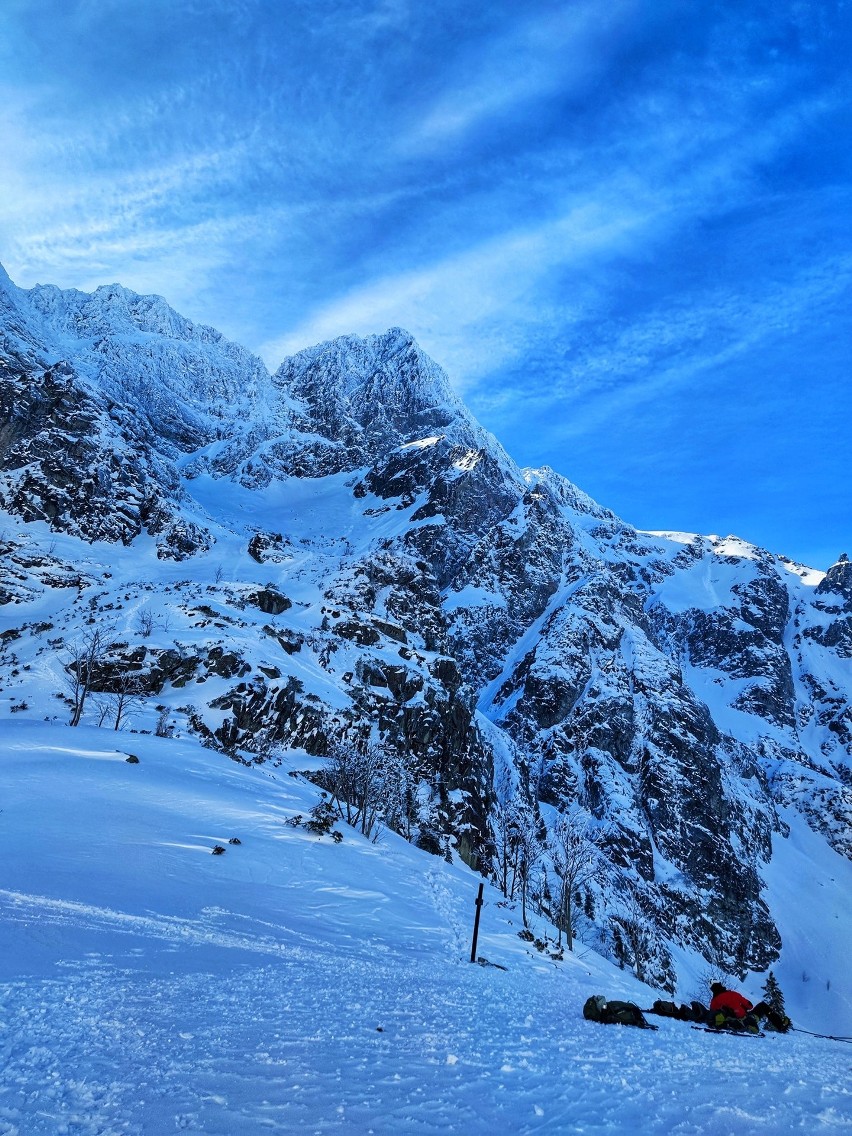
[474,547,777,979]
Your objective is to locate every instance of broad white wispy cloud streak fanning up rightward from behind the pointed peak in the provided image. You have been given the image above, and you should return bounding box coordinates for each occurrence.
[260,72,840,377]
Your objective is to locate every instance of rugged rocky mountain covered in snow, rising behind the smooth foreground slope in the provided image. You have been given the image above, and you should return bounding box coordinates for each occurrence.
[0,261,852,1003]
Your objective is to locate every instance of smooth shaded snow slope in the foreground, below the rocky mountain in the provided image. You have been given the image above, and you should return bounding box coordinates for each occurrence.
[0,722,852,1136]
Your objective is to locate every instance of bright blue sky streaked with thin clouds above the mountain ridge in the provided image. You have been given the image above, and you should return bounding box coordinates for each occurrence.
[0,0,852,567]
